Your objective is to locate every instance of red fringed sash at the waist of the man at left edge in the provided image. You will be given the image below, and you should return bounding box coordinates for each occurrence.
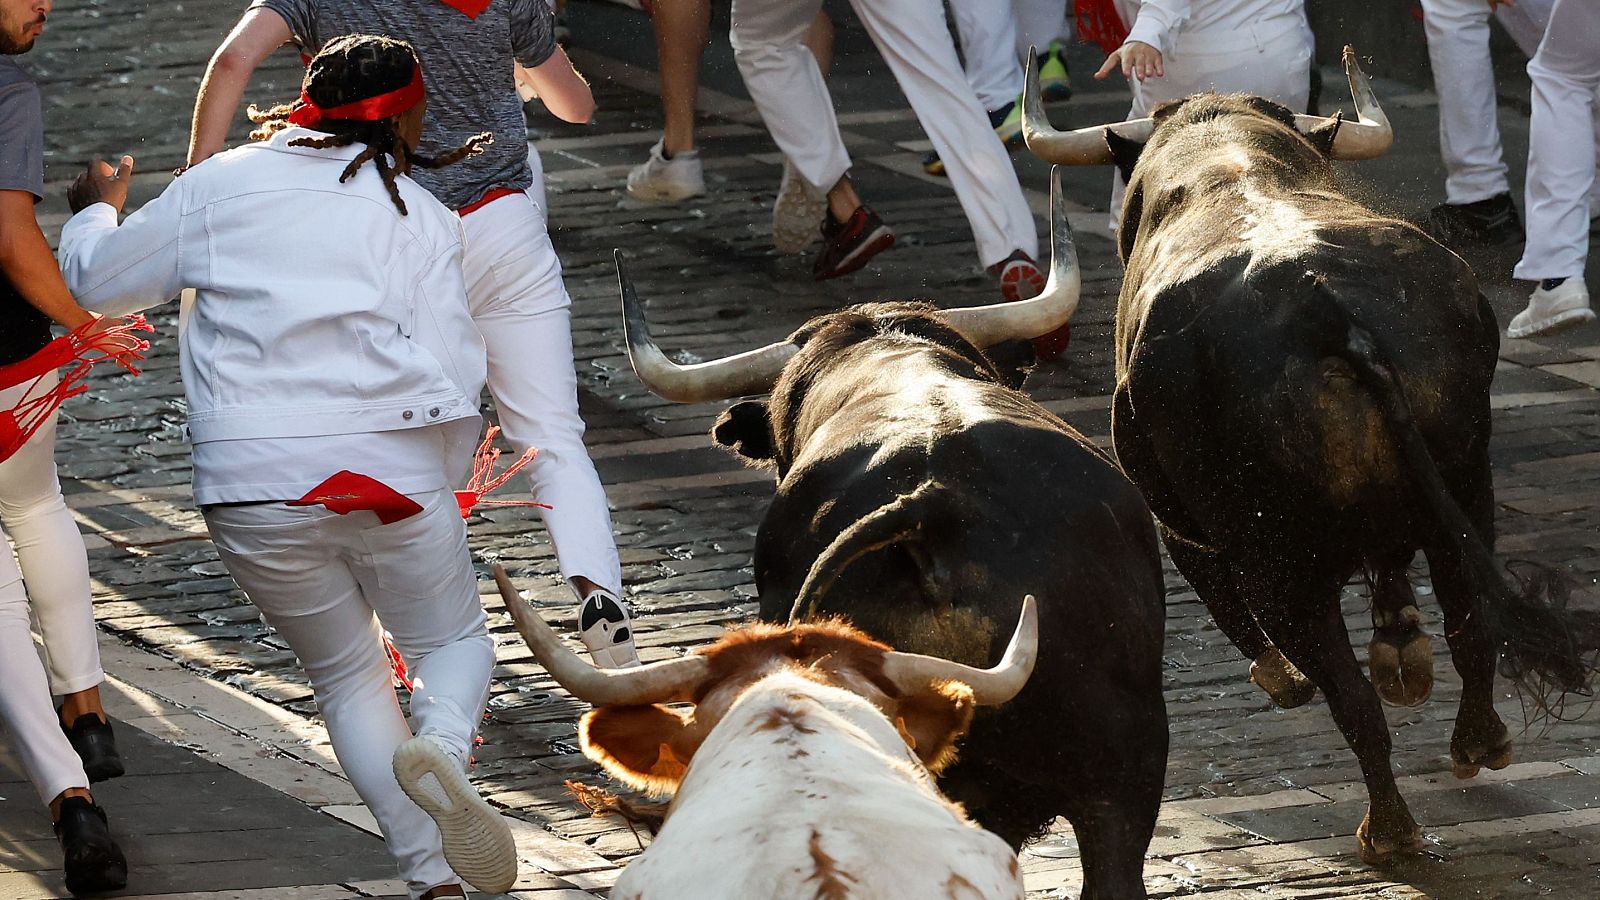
[0,315,155,461]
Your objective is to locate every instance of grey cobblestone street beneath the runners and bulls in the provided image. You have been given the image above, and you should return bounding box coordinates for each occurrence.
[0,0,1600,900]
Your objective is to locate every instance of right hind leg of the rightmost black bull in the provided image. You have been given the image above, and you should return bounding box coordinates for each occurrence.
[1427,461,1512,778]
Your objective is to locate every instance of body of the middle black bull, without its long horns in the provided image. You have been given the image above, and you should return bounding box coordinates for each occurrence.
[624,178,1166,898]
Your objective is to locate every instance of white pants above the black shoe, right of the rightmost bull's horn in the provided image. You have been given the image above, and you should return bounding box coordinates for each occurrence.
[1422,0,1600,203]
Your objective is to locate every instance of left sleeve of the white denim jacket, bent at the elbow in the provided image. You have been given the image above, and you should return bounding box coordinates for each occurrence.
[61,184,192,315]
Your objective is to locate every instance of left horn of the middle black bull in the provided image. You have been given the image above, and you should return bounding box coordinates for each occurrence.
[614,250,800,404]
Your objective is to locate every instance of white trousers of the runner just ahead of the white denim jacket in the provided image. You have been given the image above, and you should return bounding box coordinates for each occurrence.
[461,194,622,596]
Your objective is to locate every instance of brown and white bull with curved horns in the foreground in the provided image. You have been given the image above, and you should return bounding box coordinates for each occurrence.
[494,567,1038,900]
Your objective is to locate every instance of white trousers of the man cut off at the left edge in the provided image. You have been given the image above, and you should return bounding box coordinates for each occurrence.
[0,373,96,804]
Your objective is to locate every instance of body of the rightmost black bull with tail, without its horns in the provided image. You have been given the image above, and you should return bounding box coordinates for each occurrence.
[1110,94,1587,862]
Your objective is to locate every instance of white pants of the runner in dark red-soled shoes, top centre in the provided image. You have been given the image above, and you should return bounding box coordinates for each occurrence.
[732,0,1038,267]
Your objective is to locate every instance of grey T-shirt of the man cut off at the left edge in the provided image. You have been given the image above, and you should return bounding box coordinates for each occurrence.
[0,56,50,358]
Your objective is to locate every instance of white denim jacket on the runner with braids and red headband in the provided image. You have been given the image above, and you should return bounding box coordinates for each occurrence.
[61,128,485,444]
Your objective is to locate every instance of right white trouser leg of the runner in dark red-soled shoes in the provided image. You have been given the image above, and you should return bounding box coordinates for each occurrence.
[853,0,1038,266]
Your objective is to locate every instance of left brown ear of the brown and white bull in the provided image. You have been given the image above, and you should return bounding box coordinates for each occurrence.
[578,705,699,796]
